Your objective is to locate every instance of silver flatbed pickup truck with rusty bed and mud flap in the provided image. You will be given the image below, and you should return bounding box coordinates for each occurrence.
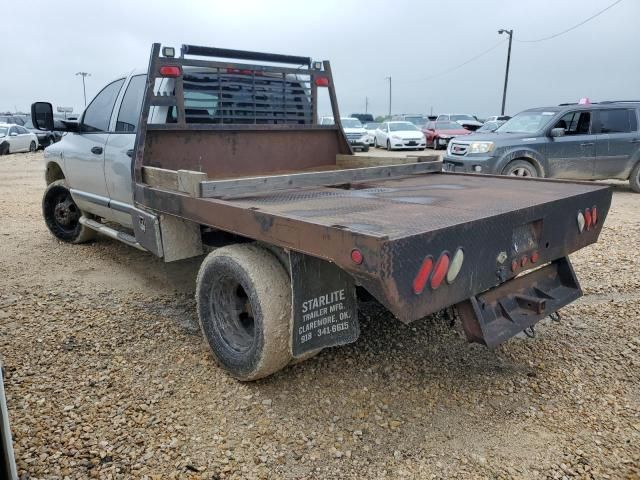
[32,44,611,380]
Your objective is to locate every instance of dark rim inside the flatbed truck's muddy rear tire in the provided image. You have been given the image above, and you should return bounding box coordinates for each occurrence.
[209,277,256,353]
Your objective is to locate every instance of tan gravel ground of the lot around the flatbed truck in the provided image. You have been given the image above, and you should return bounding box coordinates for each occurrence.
[0,152,640,479]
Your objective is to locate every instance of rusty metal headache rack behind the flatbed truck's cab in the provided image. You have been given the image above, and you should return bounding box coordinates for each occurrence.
[134,43,353,183]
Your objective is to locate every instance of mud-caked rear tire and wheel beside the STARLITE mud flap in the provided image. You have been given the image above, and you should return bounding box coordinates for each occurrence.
[196,244,292,381]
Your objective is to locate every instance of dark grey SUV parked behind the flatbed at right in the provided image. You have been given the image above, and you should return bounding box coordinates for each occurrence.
[443,102,640,193]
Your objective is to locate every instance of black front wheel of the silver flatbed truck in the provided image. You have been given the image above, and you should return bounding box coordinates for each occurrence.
[42,180,96,243]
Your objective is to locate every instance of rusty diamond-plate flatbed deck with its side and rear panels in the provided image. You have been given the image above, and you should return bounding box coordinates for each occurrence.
[136,174,611,323]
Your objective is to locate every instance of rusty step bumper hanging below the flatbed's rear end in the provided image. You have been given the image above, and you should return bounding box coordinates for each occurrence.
[456,257,582,348]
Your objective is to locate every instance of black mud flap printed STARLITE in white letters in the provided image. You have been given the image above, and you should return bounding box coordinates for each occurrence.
[289,251,360,358]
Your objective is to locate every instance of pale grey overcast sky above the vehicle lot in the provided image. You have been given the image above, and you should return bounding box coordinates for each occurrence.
[0,0,640,116]
